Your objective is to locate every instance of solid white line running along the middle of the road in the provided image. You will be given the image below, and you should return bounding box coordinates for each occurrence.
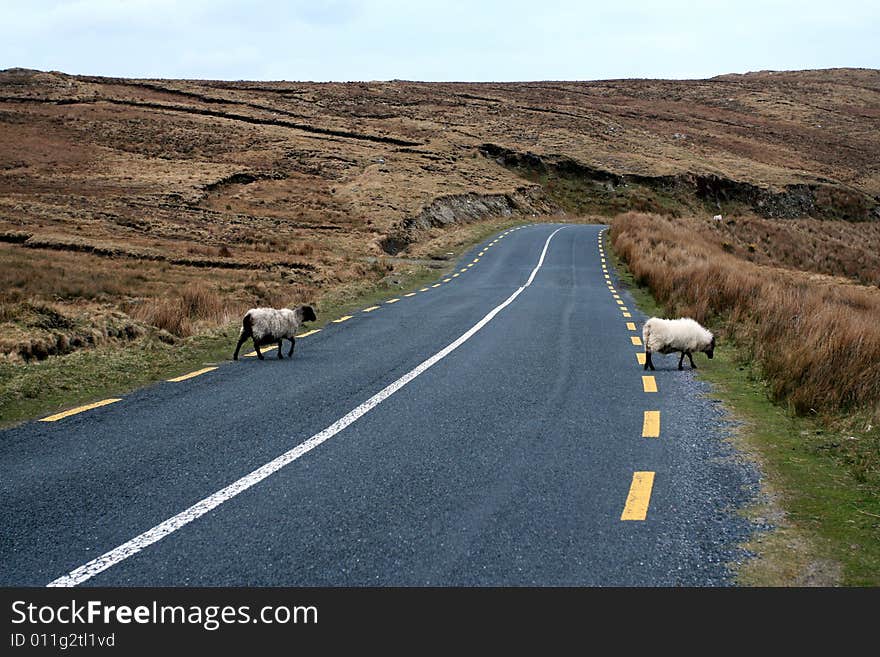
[47,226,565,587]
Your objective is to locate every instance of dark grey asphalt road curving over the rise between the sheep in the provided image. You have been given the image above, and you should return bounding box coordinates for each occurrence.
[0,224,757,586]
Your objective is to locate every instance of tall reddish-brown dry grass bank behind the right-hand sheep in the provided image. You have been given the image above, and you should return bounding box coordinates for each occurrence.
[610,213,880,417]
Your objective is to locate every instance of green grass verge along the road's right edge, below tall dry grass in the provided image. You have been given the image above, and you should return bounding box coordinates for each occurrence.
[605,231,880,586]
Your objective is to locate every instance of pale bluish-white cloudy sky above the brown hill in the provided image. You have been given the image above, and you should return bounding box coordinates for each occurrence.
[0,0,880,82]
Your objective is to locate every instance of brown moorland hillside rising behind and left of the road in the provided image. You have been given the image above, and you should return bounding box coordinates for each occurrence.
[0,69,880,362]
